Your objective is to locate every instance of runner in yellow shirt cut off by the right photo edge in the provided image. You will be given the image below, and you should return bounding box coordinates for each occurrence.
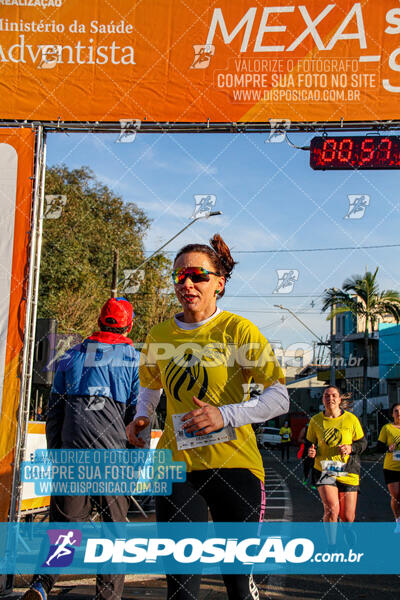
[377,404,400,533]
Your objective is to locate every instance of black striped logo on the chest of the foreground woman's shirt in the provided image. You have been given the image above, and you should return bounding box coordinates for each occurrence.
[165,352,208,402]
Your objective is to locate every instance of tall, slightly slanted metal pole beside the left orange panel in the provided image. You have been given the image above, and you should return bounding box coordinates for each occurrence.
[9,125,46,522]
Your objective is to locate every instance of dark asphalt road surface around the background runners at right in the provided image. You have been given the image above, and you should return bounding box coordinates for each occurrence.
[260,449,400,600]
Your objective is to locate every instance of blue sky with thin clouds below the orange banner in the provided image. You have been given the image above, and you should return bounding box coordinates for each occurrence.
[47,133,400,348]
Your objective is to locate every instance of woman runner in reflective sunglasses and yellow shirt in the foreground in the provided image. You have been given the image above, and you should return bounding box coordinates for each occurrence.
[127,235,289,600]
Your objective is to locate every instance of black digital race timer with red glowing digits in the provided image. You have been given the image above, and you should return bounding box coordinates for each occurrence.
[310,135,400,171]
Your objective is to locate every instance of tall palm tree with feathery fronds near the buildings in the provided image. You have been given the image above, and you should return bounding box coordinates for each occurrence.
[322,267,400,426]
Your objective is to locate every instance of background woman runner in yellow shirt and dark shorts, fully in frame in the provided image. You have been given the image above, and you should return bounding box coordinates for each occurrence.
[307,386,367,522]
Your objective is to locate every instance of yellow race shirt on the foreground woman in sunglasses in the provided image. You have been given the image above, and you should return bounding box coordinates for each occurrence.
[139,311,285,481]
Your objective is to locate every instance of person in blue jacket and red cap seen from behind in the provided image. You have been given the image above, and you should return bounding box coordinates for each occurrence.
[22,298,139,600]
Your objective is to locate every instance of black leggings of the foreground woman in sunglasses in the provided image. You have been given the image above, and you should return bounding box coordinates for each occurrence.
[156,469,265,600]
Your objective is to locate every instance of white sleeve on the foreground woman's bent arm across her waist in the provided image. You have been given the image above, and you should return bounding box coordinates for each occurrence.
[218,382,289,427]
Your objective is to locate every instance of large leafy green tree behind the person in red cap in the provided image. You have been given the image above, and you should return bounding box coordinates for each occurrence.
[38,165,177,342]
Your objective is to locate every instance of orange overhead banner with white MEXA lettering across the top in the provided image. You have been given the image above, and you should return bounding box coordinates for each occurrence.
[0,0,400,122]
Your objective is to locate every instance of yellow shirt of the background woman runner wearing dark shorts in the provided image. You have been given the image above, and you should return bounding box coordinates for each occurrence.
[307,411,364,485]
